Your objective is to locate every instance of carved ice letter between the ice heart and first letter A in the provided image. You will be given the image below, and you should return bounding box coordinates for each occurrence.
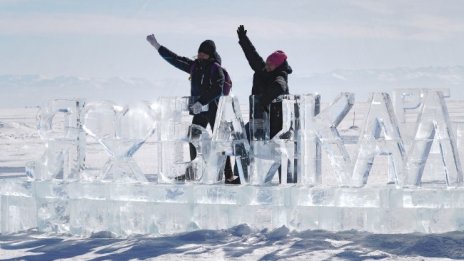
[151,97,211,183]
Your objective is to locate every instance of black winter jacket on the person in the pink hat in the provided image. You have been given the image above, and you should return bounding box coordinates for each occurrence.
[239,35,292,138]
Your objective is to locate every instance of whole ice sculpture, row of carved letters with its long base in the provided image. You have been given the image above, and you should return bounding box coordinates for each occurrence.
[5,89,464,236]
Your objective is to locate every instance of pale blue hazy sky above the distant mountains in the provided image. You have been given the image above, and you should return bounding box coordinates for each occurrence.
[0,0,464,104]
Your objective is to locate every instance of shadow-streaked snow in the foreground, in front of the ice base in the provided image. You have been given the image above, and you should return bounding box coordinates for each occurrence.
[0,225,464,261]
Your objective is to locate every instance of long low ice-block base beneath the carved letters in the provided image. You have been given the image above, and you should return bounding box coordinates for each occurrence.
[4,179,464,237]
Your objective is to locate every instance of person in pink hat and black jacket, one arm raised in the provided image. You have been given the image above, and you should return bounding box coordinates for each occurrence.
[237,25,296,182]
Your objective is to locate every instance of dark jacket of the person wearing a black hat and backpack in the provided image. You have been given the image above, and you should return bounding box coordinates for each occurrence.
[158,46,224,109]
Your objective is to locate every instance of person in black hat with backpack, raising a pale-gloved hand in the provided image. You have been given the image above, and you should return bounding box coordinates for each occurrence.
[147,34,236,183]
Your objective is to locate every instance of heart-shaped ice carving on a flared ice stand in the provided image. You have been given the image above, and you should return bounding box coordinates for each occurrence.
[84,101,155,182]
